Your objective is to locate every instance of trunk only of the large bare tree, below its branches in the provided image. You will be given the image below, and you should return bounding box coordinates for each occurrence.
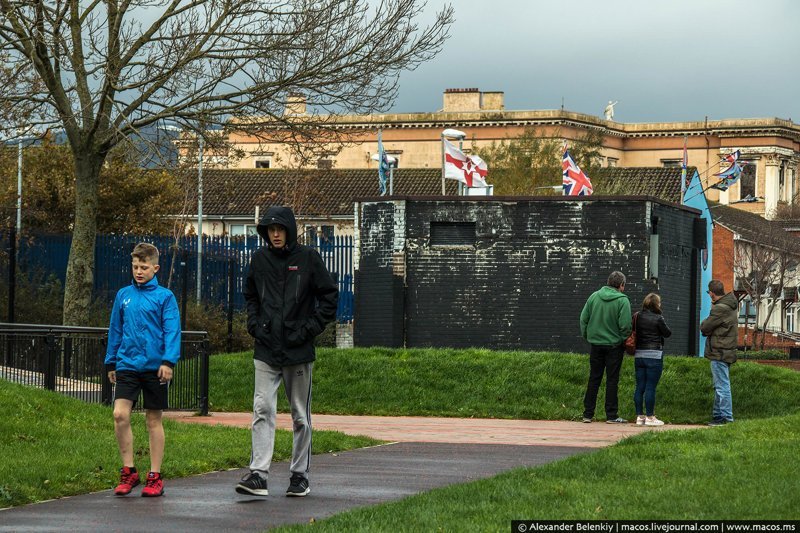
[63,153,105,326]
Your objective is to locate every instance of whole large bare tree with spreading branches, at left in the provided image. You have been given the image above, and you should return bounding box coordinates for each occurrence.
[0,0,453,324]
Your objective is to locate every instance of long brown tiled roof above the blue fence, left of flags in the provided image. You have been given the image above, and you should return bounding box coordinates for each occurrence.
[182,168,457,217]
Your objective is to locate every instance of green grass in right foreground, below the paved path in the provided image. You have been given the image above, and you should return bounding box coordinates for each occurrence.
[281,414,800,532]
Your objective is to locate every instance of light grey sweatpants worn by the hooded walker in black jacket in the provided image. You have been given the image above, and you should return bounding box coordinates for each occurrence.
[250,359,314,478]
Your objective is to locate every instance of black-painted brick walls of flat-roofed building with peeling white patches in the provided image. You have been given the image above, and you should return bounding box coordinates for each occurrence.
[354,198,699,354]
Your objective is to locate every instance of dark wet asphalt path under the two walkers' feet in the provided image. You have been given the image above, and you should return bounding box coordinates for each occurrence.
[0,443,590,532]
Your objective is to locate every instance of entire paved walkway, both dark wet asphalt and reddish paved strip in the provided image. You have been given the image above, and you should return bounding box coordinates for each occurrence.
[0,413,704,532]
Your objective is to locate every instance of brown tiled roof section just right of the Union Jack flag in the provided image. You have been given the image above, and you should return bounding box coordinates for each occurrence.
[591,167,696,204]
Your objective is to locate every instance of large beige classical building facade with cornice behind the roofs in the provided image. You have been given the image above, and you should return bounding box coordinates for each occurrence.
[219,89,800,218]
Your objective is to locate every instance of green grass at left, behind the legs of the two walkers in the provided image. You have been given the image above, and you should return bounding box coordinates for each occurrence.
[0,380,377,508]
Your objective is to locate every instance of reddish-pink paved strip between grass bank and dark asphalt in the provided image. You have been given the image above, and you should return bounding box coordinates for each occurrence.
[165,412,700,448]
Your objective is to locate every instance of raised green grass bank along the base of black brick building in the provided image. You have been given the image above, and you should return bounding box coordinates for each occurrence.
[210,348,800,424]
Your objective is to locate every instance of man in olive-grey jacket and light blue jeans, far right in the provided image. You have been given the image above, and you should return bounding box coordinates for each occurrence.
[700,279,739,426]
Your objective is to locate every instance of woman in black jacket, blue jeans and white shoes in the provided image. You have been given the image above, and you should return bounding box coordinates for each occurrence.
[633,292,672,426]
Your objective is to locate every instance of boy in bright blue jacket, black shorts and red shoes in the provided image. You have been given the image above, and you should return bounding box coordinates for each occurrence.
[105,243,181,496]
